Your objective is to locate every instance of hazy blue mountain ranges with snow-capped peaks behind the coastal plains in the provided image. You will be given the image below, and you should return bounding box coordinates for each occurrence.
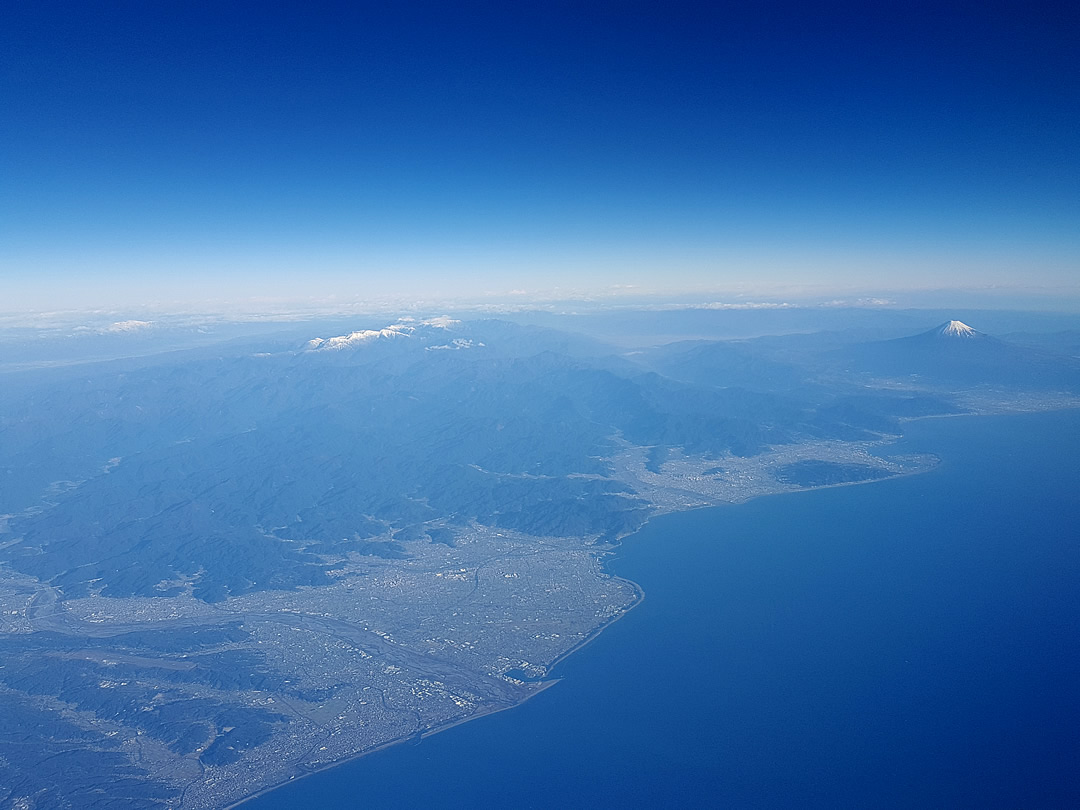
[0,319,1078,602]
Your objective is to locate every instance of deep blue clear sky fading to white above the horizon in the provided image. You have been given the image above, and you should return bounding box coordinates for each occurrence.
[0,0,1080,310]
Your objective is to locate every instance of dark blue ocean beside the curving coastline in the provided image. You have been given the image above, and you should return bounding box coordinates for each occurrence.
[245,410,1080,810]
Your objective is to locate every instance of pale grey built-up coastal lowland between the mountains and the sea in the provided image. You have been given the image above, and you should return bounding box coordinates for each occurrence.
[0,438,934,808]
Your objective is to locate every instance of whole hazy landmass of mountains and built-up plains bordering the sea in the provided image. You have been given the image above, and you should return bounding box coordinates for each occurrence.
[0,320,1071,808]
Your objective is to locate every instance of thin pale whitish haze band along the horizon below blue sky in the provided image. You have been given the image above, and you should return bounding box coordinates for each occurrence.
[6,284,1080,328]
